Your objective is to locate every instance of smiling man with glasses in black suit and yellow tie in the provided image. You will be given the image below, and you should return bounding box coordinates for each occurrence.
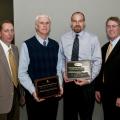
[96,17,120,120]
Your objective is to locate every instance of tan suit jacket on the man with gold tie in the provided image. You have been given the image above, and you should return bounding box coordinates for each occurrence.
[0,44,18,114]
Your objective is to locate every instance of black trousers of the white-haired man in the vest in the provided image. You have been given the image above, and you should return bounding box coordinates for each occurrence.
[26,92,58,120]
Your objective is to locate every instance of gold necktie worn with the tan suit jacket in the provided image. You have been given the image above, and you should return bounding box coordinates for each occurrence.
[8,49,18,88]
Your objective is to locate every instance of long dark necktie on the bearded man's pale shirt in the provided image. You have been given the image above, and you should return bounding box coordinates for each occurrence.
[71,34,79,61]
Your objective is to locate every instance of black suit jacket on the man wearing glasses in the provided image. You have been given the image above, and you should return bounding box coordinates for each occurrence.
[96,40,120,97]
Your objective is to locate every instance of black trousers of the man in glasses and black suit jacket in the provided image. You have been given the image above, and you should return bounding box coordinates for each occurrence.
[102,87,120,120]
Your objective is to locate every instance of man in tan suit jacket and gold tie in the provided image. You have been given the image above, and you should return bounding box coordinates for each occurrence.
[0,20,22,120]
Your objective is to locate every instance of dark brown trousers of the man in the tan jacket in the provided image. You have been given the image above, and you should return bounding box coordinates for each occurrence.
[0,88,20,120]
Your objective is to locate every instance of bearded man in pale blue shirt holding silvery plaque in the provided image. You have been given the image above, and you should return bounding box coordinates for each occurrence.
[57,12,102,120]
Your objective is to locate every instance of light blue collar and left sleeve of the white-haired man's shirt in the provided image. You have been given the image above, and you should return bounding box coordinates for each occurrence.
[18,34,48,94]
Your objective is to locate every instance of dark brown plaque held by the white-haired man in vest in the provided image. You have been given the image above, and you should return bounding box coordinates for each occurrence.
[35,76,60,99]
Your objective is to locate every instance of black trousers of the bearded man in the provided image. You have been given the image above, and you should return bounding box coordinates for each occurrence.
[64,82,95,120]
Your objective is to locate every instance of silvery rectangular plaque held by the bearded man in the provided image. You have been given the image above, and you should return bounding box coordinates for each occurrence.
[67,60,91,80]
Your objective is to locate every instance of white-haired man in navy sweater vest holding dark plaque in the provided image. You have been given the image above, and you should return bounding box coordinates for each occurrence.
[19,15,62,120]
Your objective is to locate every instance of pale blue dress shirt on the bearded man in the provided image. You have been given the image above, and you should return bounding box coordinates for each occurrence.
[57,31,102,82]
